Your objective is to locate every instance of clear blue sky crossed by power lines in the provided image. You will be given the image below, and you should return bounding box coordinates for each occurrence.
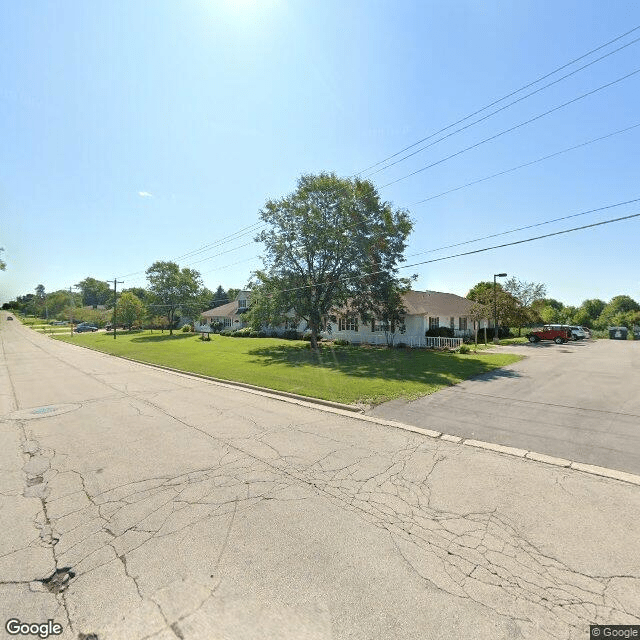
[0,0,640,304]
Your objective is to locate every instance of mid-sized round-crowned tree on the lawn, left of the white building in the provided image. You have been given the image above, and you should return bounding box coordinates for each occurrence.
[146,261,202,335]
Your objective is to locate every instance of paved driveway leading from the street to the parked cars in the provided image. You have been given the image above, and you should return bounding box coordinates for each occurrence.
[369,340,640,474]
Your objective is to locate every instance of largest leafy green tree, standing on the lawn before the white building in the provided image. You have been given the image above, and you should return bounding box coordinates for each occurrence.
[252,173,412,349]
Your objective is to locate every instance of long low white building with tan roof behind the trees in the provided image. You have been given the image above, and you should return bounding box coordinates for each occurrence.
[196,291,491,346]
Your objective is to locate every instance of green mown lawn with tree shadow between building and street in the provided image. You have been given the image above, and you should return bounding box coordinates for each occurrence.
[56,331,520,404]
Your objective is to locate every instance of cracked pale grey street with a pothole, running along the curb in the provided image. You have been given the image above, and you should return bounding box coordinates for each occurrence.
[0,314,640,640]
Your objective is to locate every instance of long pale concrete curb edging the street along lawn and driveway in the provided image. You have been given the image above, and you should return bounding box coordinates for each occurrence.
[48,332,640,486]
